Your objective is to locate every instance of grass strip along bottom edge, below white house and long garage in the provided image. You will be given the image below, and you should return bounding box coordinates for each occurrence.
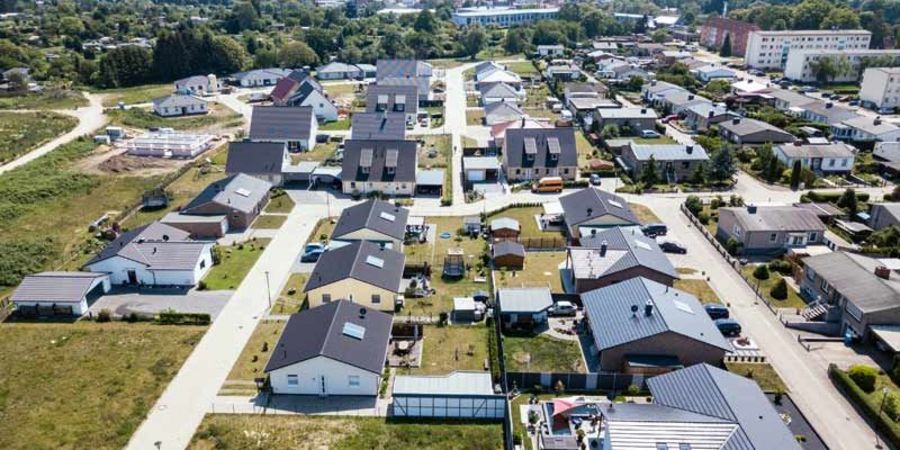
[189,415,503,450]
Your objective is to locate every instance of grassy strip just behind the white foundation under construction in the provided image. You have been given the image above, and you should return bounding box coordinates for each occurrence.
[107,103,244,130]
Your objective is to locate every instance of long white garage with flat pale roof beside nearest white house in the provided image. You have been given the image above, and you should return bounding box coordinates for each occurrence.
[392,372,506,420]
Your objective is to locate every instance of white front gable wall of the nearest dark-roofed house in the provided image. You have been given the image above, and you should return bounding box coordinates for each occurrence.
[269,356,381,396]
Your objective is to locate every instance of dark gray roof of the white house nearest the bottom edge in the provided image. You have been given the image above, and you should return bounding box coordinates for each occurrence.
[265,300,392,374]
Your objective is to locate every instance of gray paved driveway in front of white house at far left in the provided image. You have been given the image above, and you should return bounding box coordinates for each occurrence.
[90,289,234,320]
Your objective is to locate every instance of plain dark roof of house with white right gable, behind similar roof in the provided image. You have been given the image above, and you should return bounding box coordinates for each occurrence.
[250,106,315,141]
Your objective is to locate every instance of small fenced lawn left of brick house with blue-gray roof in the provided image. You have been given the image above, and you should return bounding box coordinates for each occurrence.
[503,335,586,373]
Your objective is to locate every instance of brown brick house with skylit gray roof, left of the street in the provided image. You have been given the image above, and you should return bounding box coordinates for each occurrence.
[179,173,272,230]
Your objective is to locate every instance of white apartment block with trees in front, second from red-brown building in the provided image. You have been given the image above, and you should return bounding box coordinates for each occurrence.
[784,49,900,83]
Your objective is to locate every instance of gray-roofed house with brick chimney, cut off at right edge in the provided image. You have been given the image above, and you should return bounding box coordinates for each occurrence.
[800,251,900,339]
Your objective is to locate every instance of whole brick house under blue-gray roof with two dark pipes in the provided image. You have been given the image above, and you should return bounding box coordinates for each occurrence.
[581,277,733,375]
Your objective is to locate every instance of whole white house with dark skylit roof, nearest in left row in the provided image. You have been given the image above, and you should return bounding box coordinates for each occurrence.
[265,300,392,397]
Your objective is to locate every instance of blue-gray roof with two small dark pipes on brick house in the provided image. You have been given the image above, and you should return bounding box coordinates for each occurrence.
[581,277,732,351]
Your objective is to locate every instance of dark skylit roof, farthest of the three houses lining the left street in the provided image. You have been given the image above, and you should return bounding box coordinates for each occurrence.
[331,199,409,241]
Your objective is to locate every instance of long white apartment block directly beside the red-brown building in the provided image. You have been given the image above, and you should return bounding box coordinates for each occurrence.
[744,30,872,69]
